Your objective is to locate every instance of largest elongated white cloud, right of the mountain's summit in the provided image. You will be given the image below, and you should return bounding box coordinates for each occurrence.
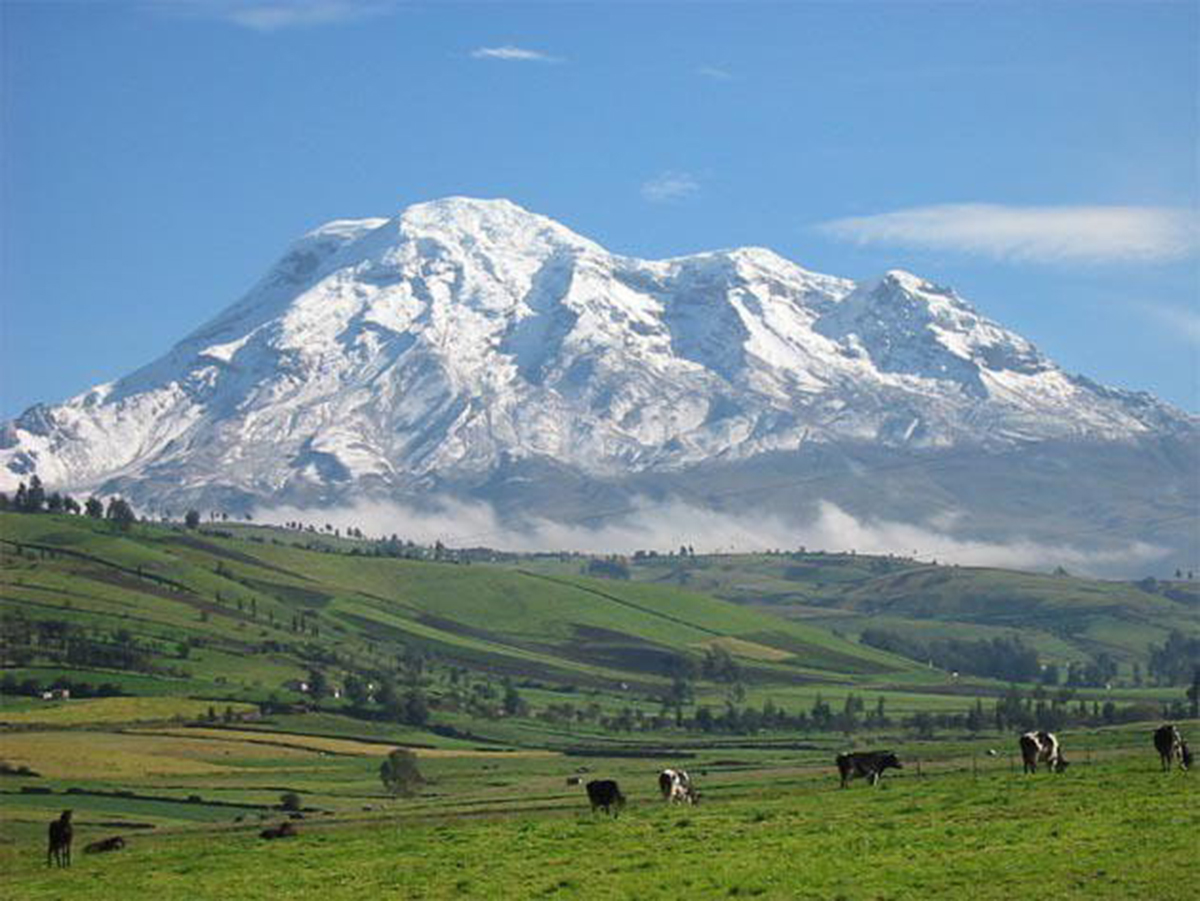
[818,204,1200,263]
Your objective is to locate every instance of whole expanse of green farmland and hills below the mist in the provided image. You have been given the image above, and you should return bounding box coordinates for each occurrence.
[0,515,1200,900]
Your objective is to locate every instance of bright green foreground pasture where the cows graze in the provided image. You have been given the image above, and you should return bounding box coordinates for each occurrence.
[0,731,1200,901]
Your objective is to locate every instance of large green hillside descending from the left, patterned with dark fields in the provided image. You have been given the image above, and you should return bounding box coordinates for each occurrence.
[0,515,913,697]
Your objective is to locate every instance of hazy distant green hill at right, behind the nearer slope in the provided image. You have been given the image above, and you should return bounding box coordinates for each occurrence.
[523,553,1200,675]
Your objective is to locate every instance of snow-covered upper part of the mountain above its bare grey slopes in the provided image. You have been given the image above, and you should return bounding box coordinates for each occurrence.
[0,198,1195,566]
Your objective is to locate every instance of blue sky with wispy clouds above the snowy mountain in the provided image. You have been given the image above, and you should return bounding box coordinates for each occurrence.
[0,0,1200,416]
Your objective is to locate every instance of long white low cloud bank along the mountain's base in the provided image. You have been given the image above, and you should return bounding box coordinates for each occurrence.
[256,499,1168,573]
